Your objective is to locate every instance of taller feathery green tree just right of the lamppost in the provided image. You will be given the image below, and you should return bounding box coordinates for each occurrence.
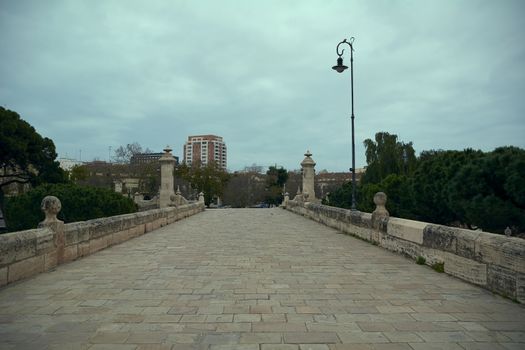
[362,132,416,183]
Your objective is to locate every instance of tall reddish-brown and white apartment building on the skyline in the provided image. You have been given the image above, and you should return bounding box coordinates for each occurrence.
[184,135,226,170]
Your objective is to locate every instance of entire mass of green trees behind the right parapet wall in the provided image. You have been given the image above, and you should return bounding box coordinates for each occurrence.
[329,133,525,233]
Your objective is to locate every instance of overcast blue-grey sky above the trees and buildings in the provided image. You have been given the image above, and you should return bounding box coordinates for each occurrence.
[0,0,525,171]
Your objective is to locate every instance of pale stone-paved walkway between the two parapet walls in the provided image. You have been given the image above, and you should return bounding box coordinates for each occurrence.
[0,209,525,350]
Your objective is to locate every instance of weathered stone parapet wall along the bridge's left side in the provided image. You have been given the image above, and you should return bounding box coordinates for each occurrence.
[0,202,204,286]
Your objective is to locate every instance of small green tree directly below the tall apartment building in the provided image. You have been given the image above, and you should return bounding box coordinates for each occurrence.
[175,163,230,205]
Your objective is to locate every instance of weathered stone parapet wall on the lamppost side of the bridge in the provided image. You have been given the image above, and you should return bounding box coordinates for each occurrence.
[285,200,525,303]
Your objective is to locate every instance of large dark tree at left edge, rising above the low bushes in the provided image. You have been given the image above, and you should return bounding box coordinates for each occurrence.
[0,107,67,200]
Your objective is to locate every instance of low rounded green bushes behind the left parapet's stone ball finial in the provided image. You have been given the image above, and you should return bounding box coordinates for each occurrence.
[5,184,137,231]
